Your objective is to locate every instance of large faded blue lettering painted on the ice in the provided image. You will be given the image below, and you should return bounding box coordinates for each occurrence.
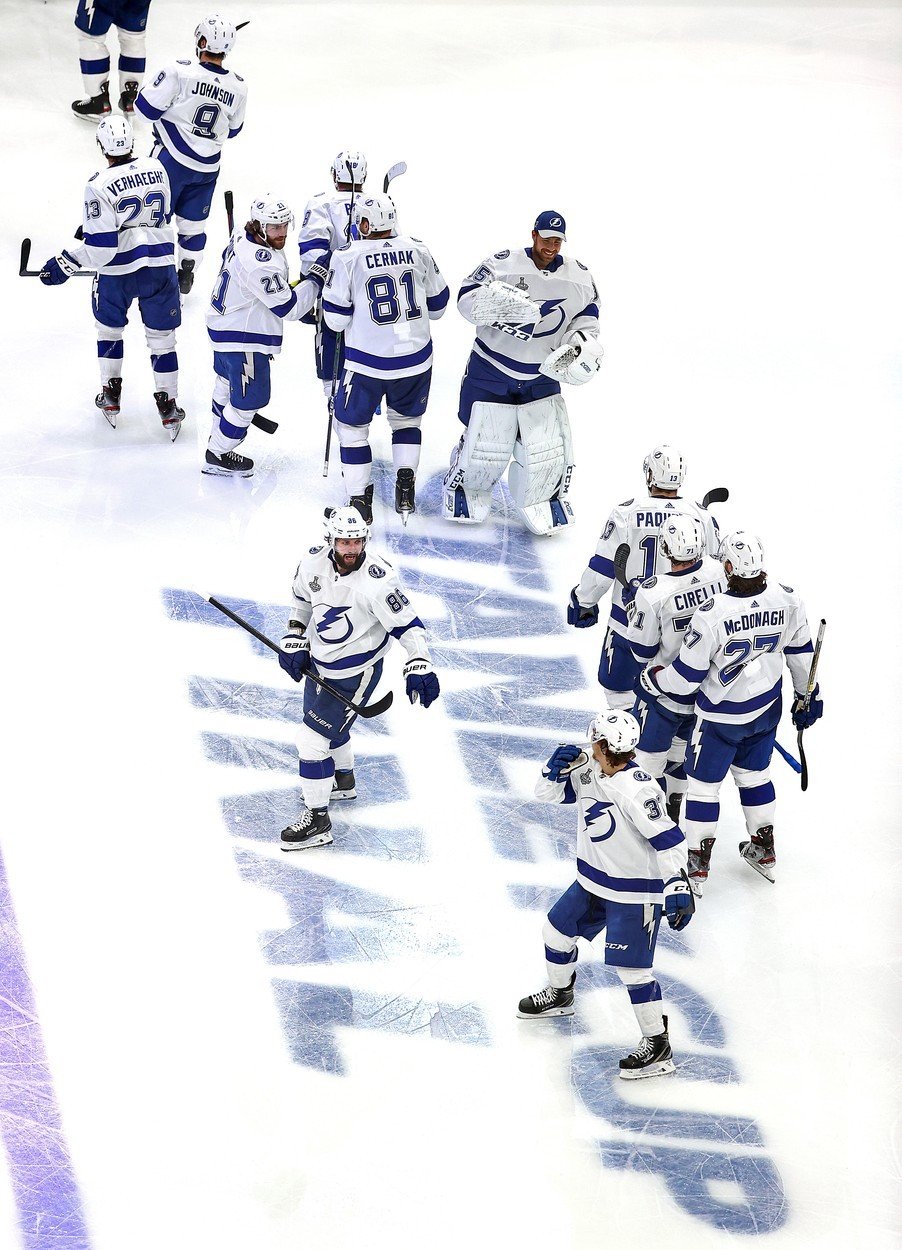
[164,478,788,1235]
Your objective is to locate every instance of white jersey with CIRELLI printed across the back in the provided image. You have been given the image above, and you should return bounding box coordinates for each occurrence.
[626,555,727,715]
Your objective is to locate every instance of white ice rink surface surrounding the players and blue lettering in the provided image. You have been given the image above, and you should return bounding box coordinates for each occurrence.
[0,0,902,1250]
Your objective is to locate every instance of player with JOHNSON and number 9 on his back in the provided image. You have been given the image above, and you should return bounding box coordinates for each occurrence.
[135,14,247,295]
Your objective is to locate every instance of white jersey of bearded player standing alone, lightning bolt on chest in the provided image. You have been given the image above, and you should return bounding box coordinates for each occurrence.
[289,545,430,678]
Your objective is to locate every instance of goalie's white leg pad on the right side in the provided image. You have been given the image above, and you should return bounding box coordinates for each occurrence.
[507,395,573,534]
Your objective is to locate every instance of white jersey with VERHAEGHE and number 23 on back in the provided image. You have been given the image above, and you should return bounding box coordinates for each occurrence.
[66,156,175,274]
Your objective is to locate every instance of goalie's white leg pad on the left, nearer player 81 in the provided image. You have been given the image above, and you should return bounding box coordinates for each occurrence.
[442,400,520,524]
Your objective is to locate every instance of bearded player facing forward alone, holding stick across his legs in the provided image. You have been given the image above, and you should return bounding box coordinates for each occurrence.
[279,508,440,851]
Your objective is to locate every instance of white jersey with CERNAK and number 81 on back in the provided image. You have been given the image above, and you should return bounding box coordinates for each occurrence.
[322,235,450,379]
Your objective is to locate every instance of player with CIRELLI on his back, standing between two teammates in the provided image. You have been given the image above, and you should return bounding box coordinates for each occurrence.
[626,513,727,825]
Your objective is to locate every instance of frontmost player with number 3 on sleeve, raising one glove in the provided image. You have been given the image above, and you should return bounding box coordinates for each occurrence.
[517,711,695,1080]
